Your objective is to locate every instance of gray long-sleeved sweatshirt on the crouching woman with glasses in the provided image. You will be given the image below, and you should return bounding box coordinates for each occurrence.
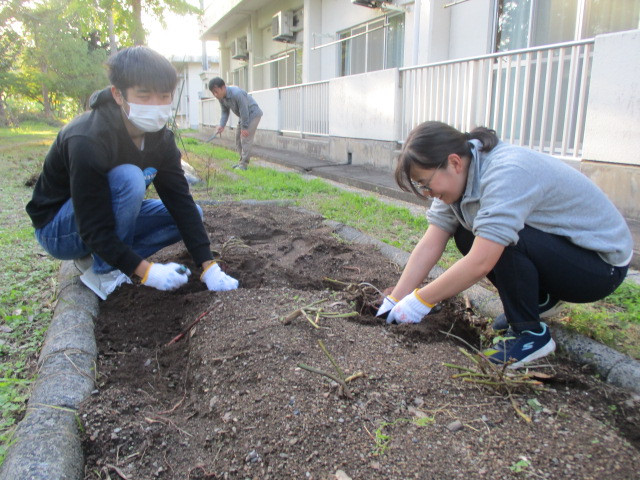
[427,140,633,266]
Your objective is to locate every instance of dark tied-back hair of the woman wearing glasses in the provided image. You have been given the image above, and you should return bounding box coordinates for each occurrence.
[395,122,499,197]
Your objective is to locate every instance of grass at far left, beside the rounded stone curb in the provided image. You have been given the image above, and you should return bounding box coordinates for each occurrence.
[0,123,60,462]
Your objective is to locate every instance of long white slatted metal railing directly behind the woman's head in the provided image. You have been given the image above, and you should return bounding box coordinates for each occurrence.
[400,39,594,158]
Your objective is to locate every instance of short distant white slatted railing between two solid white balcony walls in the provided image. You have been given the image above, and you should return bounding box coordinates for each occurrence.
[279,81,329,136]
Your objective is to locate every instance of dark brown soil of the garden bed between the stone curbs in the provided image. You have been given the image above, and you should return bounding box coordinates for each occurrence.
[81,204,640,480]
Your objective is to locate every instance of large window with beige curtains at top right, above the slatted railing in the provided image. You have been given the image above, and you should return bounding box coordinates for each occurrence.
[496,0,640,52]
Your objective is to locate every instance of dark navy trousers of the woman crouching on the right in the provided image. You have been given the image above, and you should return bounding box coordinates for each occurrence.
[454,225,628,332]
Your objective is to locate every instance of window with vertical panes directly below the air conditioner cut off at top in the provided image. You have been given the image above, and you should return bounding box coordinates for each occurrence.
[338,14,404,76]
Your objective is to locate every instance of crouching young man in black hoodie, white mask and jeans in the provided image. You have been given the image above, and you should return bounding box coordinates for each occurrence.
[26,47,238,300]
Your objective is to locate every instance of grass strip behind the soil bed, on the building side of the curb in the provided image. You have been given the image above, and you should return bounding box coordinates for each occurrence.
[183,133,640,359]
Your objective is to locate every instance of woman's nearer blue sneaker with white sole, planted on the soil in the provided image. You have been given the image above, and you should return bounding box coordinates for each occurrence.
[483,322,556,368]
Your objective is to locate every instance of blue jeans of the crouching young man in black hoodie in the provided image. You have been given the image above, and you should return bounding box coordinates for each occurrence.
[36,164,196,273]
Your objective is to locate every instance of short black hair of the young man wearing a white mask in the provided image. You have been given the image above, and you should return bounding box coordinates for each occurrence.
[106,46,178,95]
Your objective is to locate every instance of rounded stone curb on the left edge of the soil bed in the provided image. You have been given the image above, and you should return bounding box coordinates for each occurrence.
[0,262,99,480]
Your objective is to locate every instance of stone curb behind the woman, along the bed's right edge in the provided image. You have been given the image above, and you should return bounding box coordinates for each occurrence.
[325,220,640,393]
